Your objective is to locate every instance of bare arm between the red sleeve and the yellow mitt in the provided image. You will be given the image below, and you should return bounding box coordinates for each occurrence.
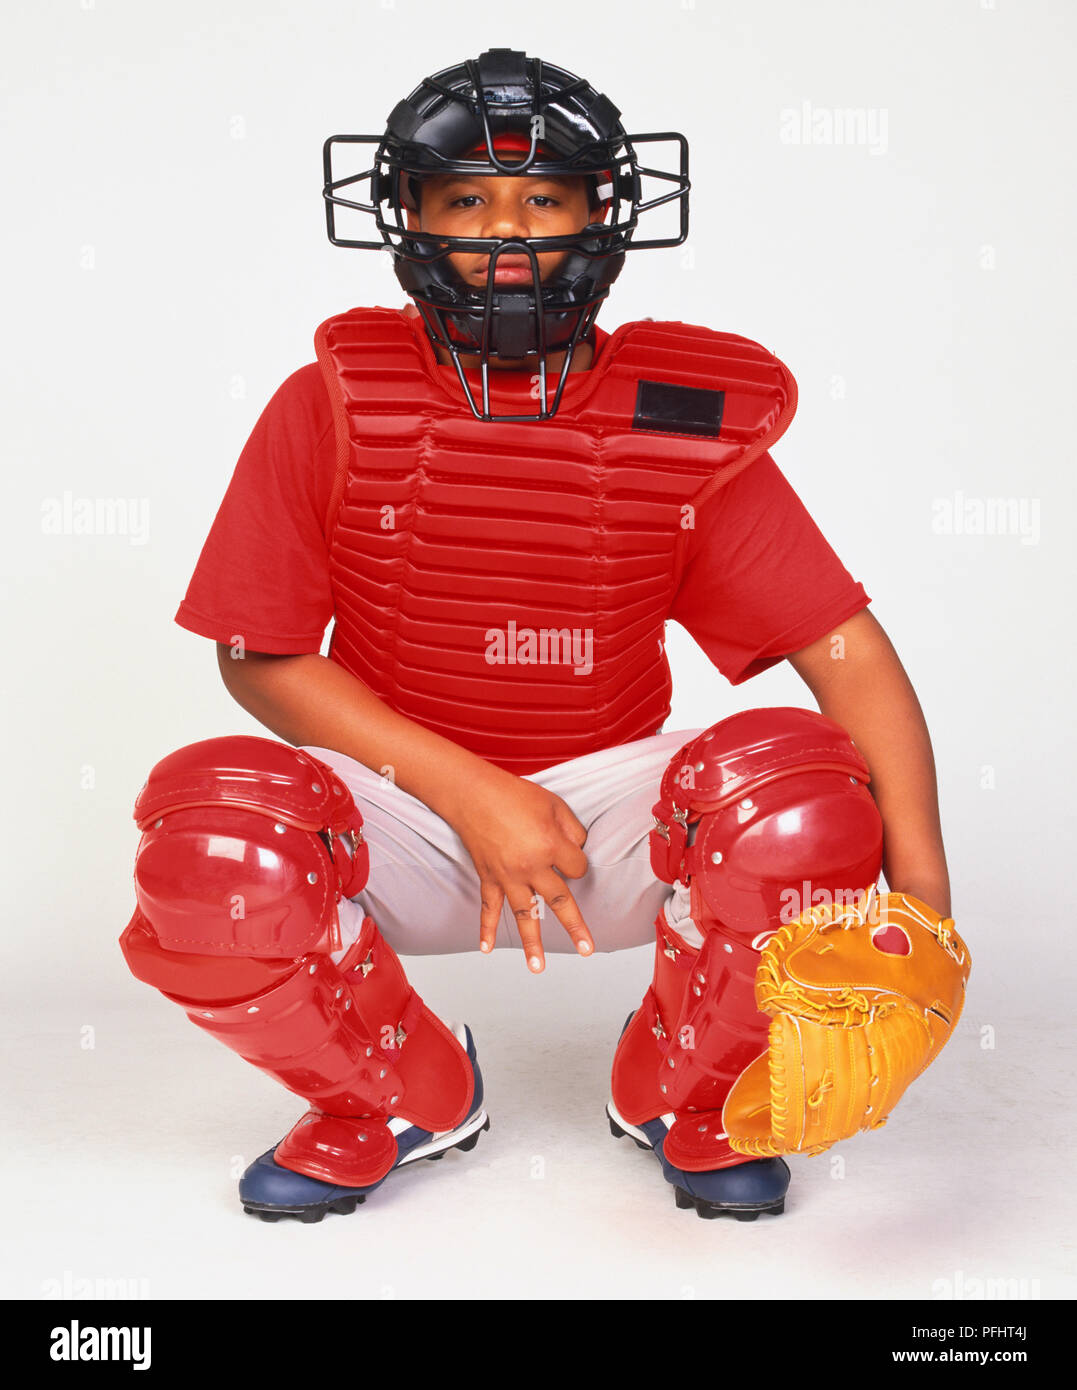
[788,609,951,916]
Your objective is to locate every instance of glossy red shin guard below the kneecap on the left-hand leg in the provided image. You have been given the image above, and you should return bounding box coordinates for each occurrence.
[121,910,474,1187]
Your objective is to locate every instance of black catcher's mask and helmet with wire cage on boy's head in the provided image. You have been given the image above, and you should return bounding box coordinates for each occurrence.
[322,49,689,420]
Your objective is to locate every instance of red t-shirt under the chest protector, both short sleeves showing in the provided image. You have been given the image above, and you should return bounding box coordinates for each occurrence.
[175,325,871,685]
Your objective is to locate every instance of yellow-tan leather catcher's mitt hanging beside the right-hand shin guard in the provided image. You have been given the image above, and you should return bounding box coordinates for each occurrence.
[723,888,970,1158]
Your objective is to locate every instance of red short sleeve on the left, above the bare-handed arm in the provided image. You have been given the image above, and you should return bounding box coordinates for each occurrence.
[175,363,336,655]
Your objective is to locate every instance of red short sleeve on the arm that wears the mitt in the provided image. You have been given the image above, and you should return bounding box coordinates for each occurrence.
[670,453,871,685]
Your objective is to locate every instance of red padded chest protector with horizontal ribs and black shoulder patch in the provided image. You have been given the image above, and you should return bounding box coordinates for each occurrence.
[314,307,796,774]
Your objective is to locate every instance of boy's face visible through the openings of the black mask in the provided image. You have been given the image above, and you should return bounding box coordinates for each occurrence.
[407,174,602,289]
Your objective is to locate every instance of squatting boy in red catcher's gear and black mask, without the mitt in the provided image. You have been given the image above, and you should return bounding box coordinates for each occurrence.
[124,49,963,1220]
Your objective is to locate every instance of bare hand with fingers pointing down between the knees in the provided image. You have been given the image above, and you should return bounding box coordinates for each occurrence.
[447,765,595,974]
